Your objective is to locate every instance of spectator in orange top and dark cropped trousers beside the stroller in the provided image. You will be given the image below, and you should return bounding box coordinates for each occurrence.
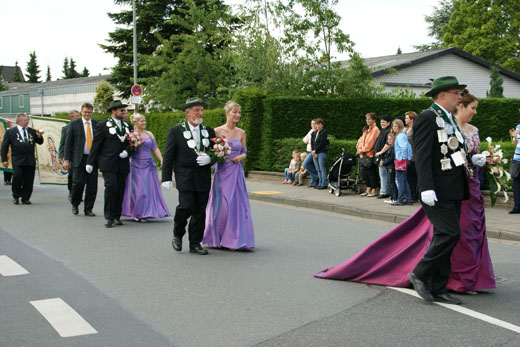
[357,112,379,197]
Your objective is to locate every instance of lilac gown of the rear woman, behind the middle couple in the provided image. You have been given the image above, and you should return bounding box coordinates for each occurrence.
[121,132,170,219]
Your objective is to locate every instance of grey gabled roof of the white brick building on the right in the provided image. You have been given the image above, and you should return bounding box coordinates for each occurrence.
[340,47,520,82]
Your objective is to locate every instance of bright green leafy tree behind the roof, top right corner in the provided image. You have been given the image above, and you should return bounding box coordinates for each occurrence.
[442,0,520,73]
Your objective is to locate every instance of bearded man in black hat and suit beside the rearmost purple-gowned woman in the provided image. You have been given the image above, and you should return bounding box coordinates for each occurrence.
[85,100,133,228]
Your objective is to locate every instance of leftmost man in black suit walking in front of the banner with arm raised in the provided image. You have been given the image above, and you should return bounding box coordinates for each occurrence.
[2,113,43,205]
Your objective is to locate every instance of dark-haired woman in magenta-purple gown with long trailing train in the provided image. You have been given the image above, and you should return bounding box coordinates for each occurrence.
[315,94,495,294]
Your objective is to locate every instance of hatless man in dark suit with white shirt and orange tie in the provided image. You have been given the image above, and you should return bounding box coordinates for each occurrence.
[63,102,98,217]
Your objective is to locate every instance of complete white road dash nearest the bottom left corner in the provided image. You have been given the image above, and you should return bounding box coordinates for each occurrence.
[30,298,97,337]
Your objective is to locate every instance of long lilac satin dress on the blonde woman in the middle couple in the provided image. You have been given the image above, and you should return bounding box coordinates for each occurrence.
[202,139,255,249]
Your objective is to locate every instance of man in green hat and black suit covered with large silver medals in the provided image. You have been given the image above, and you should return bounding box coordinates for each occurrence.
[408,76,485,304]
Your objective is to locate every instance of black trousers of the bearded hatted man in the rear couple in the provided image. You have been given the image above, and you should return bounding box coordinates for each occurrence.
[103,172,128,223]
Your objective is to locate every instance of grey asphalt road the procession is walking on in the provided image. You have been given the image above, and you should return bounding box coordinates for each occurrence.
[0,180,520,347]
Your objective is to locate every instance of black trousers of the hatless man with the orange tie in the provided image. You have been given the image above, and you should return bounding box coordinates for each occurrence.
[69,155,98,211]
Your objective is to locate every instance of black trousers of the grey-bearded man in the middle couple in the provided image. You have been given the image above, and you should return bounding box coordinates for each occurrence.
[173,191,209,248]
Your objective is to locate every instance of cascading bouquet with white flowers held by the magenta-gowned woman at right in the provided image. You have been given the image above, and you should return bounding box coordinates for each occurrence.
[482,137,511,206]
